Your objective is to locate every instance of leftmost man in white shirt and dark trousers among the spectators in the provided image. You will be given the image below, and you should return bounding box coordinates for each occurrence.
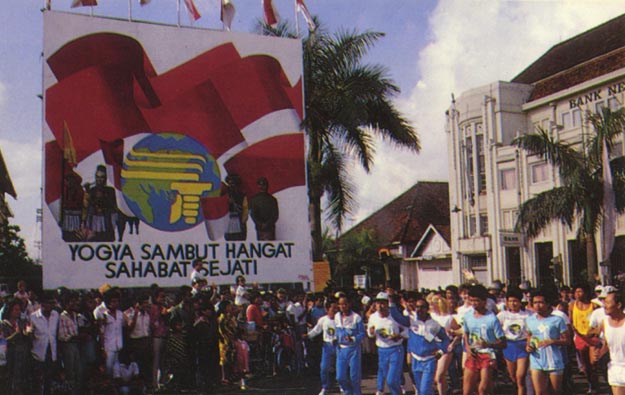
[27,294,59,394]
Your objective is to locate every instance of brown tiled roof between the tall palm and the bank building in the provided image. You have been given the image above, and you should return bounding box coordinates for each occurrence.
[341,181,451,247]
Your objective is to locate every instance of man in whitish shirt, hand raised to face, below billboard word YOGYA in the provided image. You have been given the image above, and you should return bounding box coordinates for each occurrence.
[93,288,124,376]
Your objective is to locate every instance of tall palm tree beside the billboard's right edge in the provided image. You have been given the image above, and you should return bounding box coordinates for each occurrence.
[261,23,421,260]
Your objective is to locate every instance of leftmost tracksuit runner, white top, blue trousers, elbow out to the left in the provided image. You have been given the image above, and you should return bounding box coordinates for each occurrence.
[304,301,338,395]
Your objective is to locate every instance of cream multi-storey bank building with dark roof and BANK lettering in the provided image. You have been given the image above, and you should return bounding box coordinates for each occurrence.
[446,15,625,285]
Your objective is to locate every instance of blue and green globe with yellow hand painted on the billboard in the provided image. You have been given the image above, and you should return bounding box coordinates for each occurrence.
[121,133,221,231]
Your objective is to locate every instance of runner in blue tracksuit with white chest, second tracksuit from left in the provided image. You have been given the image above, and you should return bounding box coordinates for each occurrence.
[334,296,366,395]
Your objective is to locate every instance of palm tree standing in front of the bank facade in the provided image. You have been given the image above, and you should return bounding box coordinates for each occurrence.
[513,108,625,281]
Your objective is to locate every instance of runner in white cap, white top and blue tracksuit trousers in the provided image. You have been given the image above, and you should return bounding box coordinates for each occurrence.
[367,292,408,395]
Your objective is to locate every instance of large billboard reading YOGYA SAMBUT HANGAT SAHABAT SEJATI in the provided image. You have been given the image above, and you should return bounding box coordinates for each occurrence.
[42,12,312,288]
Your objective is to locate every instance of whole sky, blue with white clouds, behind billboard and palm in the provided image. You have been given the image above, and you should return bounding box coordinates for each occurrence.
[0,0,625,256]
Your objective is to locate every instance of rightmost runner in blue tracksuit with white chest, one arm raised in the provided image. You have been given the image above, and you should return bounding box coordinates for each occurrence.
[390,294,450,395]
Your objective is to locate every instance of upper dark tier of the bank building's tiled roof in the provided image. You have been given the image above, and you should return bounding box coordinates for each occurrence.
[512,14,625,84]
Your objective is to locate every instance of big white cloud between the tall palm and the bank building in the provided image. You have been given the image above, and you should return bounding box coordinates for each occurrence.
[344,0,625,229]
